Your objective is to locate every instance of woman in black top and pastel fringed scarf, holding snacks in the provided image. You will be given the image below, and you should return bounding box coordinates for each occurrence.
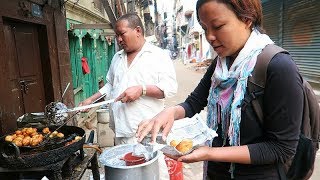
[137,0,303,180]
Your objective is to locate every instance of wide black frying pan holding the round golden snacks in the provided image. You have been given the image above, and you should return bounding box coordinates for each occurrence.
[0,126,85,169]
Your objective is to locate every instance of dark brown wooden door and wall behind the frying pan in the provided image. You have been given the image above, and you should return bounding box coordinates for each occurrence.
[0,0,73,134]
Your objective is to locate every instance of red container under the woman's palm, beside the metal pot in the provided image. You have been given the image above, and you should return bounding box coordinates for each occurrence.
[164,156,183,180]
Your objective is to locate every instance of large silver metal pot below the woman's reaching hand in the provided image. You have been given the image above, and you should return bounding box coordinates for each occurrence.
[99,144,159,180]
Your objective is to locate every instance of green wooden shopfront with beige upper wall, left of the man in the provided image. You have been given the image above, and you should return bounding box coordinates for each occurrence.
[66,0,115,105]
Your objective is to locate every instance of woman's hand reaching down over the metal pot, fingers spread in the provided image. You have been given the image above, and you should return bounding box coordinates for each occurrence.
[136,107,176,142]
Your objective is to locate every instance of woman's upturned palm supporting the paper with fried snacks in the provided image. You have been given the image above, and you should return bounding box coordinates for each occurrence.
[166,146,211,163]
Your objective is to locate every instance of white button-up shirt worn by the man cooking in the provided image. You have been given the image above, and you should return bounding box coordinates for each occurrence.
[99,42,178,137]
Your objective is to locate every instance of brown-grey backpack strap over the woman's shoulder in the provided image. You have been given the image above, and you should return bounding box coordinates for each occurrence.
[248,44,288,125]
